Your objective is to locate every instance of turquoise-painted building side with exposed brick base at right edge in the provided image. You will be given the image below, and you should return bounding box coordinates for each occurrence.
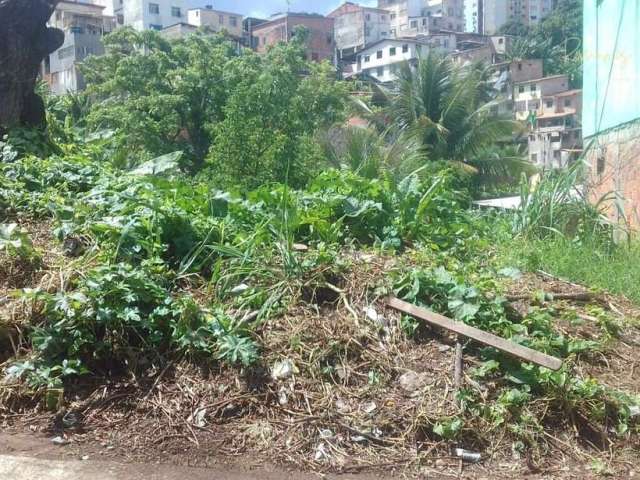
[582,0,640,229]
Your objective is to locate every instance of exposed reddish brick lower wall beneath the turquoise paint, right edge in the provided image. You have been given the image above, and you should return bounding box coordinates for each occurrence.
[584,121,640,229]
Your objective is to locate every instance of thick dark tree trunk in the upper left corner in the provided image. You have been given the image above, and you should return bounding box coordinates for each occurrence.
[0,0,64,129]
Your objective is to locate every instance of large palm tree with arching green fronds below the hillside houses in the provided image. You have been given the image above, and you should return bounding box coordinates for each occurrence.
[385,52,517,165]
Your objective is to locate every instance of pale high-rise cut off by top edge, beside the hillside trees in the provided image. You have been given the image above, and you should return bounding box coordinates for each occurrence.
[480,0,557,35]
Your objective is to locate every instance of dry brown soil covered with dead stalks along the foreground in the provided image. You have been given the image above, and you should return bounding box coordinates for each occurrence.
[0,221,640,479]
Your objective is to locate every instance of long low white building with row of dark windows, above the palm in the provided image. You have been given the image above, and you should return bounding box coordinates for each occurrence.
[353,34,456,83]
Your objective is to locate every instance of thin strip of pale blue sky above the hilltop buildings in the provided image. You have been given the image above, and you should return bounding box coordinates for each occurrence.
[191,0,378,18]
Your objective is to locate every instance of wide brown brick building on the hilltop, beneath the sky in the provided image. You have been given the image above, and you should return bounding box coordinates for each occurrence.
[253,13,335,62]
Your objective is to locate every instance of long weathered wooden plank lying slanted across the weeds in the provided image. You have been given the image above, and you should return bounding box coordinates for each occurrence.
[387,298,562,370]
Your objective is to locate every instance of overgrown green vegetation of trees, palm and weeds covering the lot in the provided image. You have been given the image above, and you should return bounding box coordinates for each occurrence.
[0,17,639,472]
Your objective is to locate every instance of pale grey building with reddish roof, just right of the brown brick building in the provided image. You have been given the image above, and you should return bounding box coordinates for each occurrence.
[327,2,391,60]
